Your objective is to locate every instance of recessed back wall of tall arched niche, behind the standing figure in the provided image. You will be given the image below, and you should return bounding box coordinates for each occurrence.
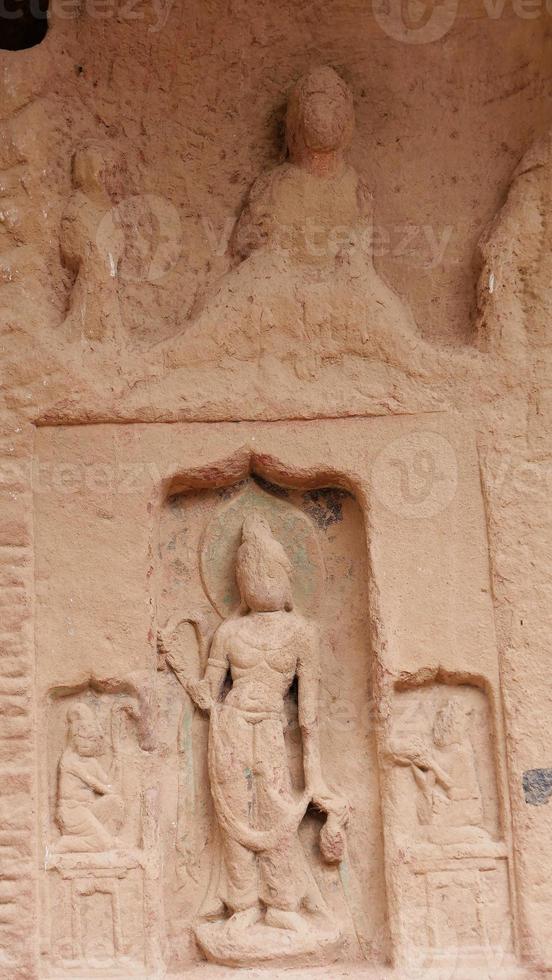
[155,464,388,960]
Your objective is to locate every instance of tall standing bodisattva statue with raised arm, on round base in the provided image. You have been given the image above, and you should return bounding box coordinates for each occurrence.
[162,511,348,965]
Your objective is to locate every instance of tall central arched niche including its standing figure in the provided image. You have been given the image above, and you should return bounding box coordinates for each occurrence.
[159,478,387,967]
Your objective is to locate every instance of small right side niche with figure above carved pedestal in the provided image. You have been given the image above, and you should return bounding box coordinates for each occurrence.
[385,683,513,966]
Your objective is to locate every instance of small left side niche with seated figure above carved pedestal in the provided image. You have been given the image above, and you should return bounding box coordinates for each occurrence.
[43,679,161,975]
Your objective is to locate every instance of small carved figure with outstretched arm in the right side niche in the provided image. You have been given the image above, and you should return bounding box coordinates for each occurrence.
[392,698,484,839]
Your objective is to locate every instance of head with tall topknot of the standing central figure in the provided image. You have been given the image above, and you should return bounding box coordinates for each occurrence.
[236,512,293,612]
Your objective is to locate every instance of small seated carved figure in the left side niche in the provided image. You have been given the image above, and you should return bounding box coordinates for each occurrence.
[55,702,124,852]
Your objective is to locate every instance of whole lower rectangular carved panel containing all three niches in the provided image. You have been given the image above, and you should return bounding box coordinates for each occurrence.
[37,416,517,976]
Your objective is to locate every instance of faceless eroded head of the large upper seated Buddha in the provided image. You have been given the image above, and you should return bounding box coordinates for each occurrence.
[286,67,354,162]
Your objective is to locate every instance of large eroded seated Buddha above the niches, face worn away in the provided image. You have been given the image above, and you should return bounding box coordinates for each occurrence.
[164,67,420,378]
